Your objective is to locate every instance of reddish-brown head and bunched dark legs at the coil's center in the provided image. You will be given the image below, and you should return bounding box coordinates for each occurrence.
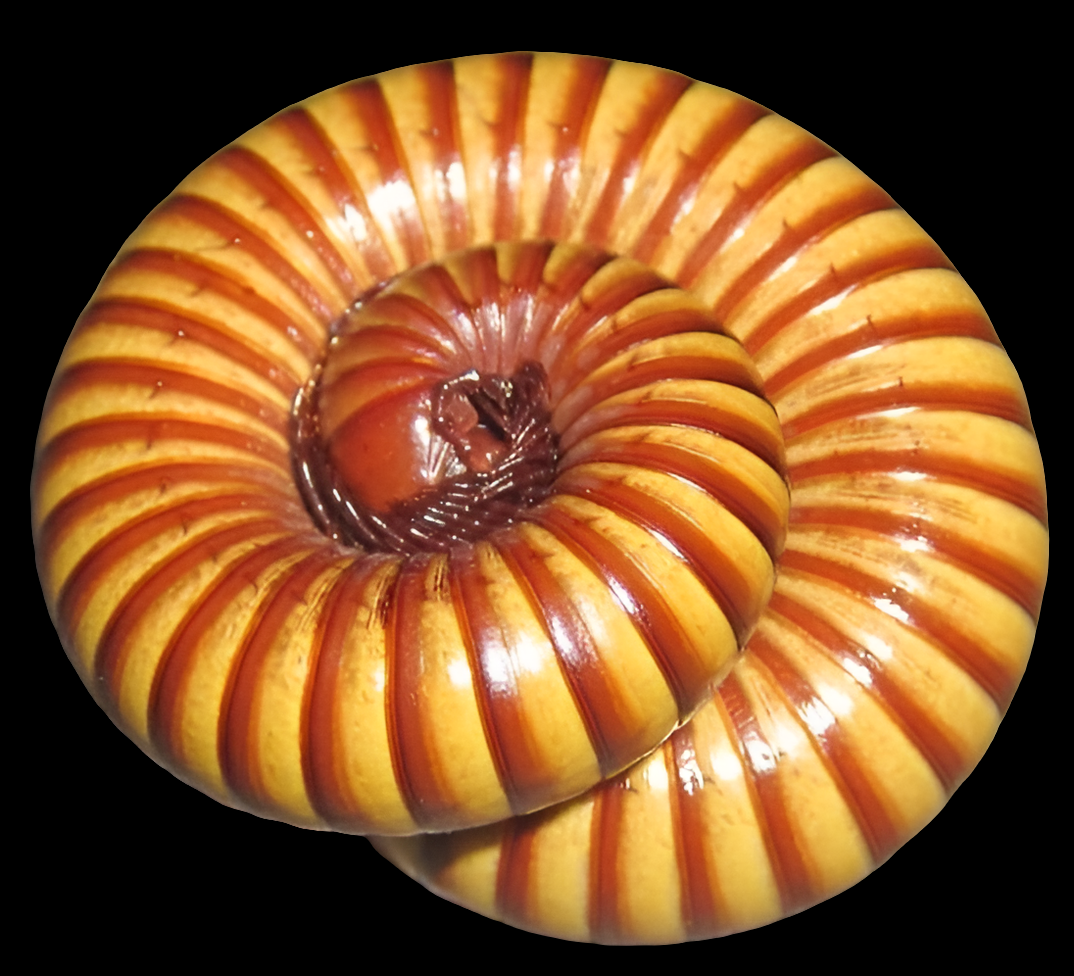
[292,339,557,553]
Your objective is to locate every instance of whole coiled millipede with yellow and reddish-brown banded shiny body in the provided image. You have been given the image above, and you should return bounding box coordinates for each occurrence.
[32,55,1047,943]
